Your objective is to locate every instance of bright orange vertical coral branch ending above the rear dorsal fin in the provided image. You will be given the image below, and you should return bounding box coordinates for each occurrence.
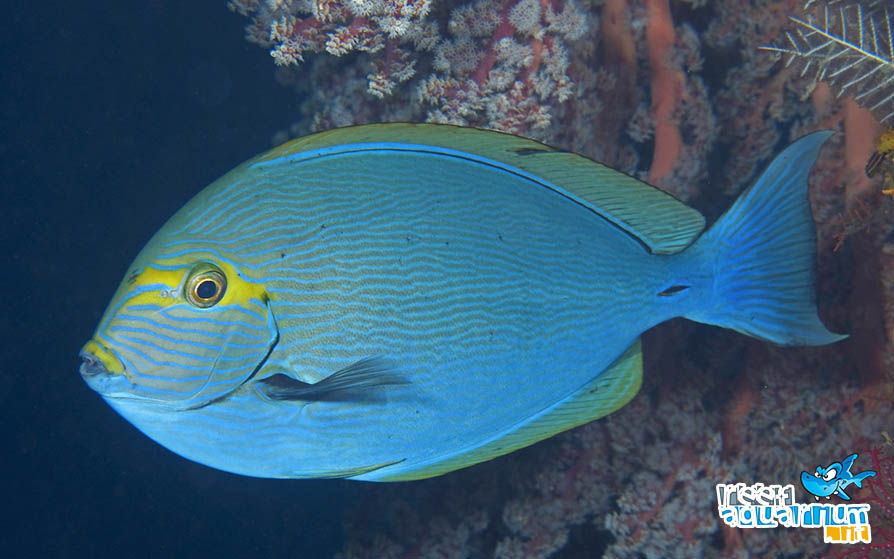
[646,0,684,183]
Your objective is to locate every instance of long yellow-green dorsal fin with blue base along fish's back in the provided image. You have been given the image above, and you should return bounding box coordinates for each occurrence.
[251,123,705,254]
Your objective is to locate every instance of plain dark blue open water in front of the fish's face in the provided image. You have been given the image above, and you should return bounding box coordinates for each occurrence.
[0,0,362,558]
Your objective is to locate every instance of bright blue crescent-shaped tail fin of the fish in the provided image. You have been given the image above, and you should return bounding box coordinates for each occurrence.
[686,131,847,345]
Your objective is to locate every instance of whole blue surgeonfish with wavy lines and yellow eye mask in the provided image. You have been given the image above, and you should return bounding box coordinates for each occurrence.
[80,124,844,481]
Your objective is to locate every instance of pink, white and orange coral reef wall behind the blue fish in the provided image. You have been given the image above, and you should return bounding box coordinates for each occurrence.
[230,0,894,559]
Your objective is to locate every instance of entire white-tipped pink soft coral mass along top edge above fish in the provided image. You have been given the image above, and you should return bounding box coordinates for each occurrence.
[230,0,587,137]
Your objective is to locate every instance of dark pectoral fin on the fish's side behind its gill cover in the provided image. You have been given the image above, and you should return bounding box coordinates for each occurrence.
[259,357,409,401]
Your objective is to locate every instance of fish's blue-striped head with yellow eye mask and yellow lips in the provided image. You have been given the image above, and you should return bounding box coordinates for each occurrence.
[80,243,278,413]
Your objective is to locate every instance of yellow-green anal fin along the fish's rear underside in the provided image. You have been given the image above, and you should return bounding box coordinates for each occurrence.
[370,338,643,481]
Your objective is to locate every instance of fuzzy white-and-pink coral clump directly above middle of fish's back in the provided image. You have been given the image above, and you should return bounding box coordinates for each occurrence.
[417,0,587,135]
